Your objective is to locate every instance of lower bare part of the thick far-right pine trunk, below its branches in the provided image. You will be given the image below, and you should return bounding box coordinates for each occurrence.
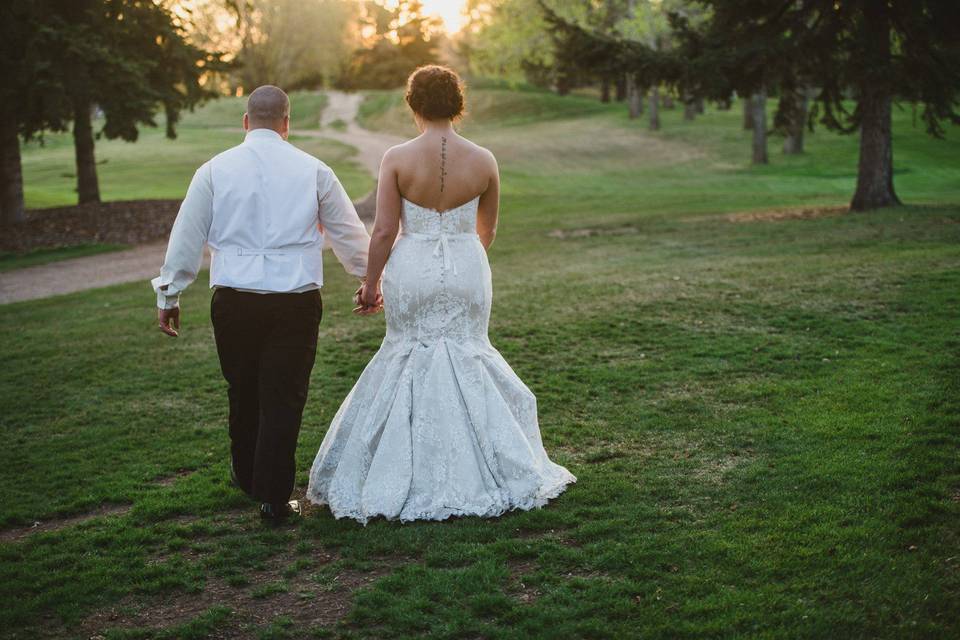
[850,92,900,211]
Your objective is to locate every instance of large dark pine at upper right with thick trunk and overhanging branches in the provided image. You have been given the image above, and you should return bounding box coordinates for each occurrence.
[674,0,960,211]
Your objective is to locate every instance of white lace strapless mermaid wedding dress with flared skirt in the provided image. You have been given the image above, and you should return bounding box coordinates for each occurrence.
[307,198,576,524]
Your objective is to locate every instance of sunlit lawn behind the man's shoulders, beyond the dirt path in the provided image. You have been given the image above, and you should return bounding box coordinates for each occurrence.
[23,92,373,209]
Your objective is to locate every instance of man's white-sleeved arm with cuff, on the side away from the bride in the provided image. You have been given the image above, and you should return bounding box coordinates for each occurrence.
[151,163,213,322]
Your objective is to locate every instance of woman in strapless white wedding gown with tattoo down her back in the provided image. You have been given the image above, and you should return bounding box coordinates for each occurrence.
[307,65,576,524]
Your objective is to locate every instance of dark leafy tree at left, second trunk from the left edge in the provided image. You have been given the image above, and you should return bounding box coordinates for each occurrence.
[52,0,222,204]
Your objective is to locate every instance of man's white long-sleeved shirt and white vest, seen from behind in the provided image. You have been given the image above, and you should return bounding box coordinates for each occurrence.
[151,129,370,309]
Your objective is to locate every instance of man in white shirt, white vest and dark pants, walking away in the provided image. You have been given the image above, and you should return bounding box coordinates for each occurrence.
[152,85,370,520]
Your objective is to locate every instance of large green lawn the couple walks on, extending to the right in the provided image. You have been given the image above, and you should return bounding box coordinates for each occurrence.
[0,91,960,639]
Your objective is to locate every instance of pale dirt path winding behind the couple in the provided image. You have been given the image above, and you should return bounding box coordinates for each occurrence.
[0,91,403,304]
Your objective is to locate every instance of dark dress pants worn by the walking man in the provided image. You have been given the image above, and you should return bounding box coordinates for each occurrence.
[210,287,323,504]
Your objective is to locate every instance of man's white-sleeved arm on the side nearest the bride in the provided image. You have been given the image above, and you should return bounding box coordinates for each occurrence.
[317,167,370,278]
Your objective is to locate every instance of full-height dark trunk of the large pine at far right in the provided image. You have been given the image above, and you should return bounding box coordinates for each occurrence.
[850,2,900,211]
